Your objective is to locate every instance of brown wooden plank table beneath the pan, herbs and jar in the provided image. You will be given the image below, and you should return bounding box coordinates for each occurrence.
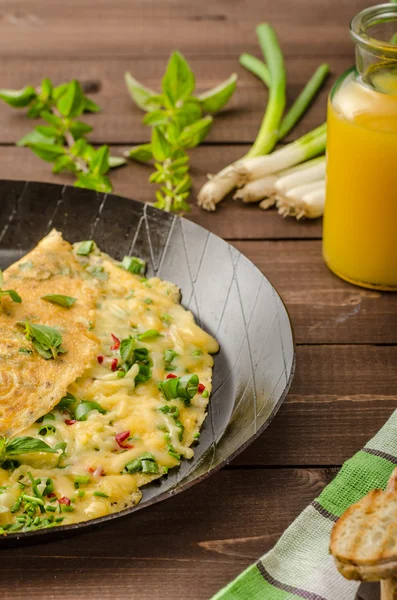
[0,0,397,600]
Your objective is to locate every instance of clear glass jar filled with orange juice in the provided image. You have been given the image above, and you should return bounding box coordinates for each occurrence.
[323,4,397,290]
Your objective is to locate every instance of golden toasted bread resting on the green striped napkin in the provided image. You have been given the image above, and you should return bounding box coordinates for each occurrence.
[330,469,397,581]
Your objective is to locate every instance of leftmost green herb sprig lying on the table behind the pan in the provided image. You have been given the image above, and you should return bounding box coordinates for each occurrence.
[0,78,126,192]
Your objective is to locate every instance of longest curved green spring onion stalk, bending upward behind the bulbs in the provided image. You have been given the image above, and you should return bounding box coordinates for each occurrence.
[246,23,286,158]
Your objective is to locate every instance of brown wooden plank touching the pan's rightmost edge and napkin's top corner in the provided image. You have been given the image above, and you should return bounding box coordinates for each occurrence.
[234,346,397,466]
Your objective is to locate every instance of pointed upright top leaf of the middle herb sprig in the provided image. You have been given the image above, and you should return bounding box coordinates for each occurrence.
[161,52,195,106]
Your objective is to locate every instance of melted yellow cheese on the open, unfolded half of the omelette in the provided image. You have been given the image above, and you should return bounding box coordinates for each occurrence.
[0,241,218,527]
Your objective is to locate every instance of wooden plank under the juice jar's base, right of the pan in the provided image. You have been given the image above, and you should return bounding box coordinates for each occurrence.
[235,241,397,344]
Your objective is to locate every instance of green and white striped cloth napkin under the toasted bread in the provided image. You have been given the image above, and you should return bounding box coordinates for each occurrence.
[212,411,397,600]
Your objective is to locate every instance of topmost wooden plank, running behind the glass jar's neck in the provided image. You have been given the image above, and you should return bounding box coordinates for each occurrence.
[0,0,368,59]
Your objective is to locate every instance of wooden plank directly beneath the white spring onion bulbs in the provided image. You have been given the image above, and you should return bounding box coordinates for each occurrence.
[0,146,321,239]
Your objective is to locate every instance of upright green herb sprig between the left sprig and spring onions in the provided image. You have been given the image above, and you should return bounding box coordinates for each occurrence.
[125,52,237,212]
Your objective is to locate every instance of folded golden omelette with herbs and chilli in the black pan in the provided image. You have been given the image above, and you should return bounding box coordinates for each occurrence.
[0,232,218,535]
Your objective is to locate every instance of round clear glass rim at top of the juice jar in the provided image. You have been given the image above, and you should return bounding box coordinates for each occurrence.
[350,3,397,60]
